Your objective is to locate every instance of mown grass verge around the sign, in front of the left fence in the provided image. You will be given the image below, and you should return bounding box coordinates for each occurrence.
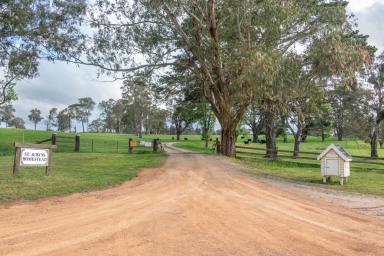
[0,152,165,202]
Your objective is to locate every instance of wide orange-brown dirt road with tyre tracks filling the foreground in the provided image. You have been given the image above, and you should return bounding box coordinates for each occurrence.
[0,145,384,256]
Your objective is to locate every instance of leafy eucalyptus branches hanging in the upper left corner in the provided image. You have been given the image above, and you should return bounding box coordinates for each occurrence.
[0,0,86,105]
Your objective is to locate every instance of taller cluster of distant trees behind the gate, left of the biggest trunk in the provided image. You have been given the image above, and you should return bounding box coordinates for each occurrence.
[89,73,216,141]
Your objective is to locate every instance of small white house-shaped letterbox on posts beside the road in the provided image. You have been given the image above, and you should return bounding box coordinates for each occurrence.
[317,144,352,185]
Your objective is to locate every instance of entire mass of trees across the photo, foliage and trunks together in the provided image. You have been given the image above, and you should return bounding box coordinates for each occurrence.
[0,0,384,157]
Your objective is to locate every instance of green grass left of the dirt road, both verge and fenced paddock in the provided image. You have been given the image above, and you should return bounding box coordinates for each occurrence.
[0,129,168,202]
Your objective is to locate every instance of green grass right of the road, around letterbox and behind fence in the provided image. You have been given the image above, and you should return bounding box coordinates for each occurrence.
[176,134,384,196]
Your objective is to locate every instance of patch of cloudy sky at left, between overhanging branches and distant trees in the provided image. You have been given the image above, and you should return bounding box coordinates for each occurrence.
[13,61,121,128]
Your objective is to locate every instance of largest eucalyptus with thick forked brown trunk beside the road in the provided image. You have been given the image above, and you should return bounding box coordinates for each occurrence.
[82,0,354,156]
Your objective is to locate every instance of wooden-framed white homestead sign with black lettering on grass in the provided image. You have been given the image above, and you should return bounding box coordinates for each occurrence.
[13,144,56,176]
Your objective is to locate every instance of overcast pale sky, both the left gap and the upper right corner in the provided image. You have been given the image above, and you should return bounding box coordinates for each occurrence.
[5,0,384,129]
